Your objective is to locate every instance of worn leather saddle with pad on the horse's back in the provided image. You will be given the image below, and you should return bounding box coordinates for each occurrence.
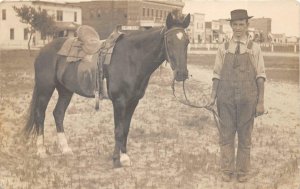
[57,26,123,109]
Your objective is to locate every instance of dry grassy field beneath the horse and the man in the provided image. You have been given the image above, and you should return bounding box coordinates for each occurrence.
[0,51,300,189]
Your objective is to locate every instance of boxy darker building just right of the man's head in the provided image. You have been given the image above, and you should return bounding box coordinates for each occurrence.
[249,18,272,42]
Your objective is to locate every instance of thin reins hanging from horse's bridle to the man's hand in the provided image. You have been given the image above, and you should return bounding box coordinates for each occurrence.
[171,77,223,136]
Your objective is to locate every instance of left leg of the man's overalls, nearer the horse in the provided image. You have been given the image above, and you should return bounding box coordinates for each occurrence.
[217,101,236,174]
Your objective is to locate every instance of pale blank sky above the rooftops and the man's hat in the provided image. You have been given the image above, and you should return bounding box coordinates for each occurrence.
[0,0,300,37]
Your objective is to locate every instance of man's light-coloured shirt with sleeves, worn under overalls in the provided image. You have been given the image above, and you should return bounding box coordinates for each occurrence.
[213,38,266,79]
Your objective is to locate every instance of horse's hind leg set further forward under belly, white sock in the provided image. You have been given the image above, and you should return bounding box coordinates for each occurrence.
[53,84,73,155]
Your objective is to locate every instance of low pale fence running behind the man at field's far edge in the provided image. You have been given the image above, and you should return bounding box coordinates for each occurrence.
[189,43,299,53]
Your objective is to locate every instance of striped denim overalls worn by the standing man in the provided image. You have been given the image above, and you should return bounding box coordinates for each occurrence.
[217,41,258,175]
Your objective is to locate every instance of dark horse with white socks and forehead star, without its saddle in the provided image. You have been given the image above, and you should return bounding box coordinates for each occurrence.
[24,13,190,168]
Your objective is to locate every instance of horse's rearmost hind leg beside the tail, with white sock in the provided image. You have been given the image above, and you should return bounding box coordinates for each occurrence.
[35,87,54,157]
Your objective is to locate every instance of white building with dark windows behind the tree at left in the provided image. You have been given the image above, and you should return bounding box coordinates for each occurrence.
[0,0,82,49]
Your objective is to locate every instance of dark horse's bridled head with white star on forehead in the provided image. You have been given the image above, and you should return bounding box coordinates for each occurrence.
[164,13,190,81]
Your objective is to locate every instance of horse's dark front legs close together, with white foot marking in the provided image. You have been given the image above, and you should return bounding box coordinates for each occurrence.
[113,100,138,168]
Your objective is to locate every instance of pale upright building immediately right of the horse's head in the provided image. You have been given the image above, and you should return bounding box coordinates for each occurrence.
[187,13,205,43]
